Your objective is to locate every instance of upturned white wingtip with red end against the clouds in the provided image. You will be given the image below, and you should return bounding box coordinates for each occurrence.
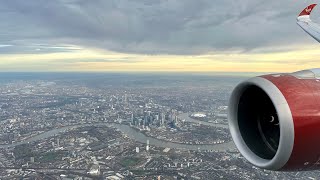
[297,4,320,42]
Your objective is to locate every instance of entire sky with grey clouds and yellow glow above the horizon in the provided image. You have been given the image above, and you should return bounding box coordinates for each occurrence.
[0,0,320,72]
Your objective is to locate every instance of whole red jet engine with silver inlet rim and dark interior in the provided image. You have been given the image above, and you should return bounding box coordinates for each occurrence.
[228,69,320,171]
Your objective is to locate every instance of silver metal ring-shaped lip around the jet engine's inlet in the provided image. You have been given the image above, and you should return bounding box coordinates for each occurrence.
[228,77,294,170]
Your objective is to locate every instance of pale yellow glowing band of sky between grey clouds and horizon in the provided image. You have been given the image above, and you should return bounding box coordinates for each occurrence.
[0,43,320,72]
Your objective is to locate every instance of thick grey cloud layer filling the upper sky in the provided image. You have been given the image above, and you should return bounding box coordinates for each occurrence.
[0,0,312,54]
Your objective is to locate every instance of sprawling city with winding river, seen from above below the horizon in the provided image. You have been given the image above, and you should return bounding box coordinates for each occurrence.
[0,73,319,180]
